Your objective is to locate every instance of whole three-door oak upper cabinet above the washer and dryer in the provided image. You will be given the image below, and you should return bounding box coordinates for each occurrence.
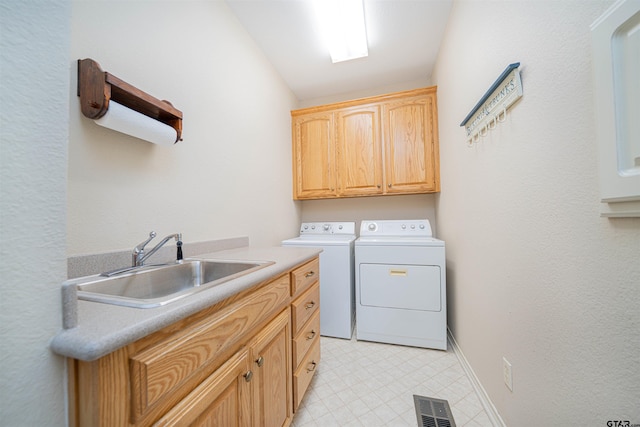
[291,86,440,199]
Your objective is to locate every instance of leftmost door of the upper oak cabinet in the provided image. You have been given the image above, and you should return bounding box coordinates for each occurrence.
[292,112,336,199]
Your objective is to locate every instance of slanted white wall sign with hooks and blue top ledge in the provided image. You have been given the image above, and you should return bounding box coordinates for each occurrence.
[460,62,522,147]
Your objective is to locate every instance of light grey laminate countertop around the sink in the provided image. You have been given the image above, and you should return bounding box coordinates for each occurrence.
[51,246,322,361]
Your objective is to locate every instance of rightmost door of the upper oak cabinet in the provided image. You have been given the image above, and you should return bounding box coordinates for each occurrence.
[383,94,440,193]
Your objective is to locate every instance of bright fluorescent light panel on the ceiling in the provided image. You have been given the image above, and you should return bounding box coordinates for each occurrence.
[314,0,369,63]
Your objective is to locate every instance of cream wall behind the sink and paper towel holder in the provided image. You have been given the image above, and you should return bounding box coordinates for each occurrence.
[68,0,300,255]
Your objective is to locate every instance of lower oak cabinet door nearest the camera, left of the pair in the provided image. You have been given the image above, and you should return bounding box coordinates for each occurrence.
[154,348,253,427]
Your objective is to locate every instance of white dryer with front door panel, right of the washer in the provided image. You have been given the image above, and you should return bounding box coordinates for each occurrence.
[355,220,447,350]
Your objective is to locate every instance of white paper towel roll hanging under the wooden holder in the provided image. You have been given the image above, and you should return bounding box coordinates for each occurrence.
[94,100,178,146]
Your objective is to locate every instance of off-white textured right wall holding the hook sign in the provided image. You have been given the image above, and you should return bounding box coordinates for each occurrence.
[433,0,640,426]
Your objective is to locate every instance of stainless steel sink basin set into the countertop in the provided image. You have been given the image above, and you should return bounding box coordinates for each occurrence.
[77,260,273,308]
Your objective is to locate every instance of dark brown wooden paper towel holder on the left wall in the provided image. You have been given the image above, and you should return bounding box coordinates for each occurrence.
[78,58,182,142]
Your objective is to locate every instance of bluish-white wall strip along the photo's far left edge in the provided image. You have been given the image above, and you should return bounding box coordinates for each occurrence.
[0,0,71,426]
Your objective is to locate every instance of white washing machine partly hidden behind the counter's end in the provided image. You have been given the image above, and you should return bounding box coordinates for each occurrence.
[282,222,356,339]
